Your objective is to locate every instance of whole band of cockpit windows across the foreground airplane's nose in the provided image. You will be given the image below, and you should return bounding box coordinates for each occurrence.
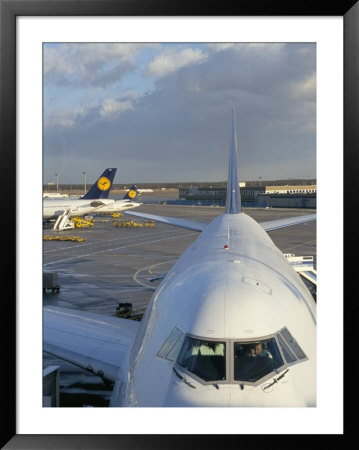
[174,327,308,386]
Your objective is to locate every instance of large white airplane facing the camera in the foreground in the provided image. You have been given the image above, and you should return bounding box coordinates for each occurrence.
[43,108,316,407]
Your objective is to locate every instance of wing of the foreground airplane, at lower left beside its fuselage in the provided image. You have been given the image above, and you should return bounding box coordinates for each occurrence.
[43,307,140,381]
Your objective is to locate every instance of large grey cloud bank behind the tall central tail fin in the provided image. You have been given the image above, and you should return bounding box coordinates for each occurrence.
[44,44,316,183]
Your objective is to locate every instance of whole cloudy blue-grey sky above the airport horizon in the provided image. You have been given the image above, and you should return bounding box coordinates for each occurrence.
[43,43,316,184]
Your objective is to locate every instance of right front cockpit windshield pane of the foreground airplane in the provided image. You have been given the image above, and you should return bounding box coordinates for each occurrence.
[234,338,284,382]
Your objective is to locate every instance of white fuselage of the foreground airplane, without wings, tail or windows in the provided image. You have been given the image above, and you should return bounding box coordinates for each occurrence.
[111,213,316,407]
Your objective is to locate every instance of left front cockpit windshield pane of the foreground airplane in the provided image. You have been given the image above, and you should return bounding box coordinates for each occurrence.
[178,336,226,381]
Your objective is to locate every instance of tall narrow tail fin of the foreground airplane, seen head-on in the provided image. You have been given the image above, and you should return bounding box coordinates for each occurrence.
[226,107,242,214]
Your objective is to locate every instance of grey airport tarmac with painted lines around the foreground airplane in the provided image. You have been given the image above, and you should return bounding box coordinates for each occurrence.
[43,204,316,406]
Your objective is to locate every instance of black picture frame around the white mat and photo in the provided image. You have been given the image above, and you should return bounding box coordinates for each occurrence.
[0,0,359,449]
